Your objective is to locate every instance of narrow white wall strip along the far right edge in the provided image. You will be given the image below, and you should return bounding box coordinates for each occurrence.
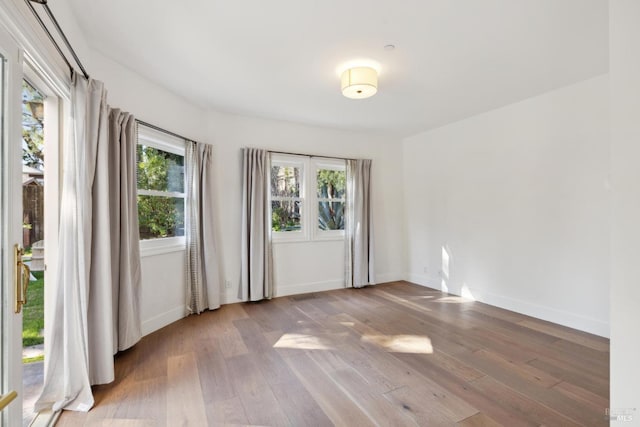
[609,0,640,426]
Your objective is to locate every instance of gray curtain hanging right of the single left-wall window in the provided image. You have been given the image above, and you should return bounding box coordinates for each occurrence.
[185,141,221,314]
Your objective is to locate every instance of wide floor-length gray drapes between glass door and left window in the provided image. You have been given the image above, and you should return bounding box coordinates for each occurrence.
[35,75,141,411]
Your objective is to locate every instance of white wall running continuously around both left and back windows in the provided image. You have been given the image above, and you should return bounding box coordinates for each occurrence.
[75,51,405,334]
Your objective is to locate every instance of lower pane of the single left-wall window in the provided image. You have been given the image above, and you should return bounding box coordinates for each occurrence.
[138,196,184,240]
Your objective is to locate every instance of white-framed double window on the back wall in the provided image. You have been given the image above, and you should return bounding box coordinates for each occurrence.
[270,155,346,241]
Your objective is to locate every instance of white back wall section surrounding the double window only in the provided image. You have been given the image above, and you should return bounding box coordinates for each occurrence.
[207,112,404,302]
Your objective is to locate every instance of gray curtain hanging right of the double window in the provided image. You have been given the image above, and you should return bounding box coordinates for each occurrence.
[345,159,375,288]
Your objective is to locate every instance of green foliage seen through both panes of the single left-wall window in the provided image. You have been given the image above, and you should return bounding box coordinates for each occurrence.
[136,144,184,239]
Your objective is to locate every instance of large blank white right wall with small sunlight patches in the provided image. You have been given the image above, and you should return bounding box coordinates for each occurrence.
[404,76,609,336]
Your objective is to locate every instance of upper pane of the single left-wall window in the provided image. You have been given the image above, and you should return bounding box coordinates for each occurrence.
[136,144,184,193]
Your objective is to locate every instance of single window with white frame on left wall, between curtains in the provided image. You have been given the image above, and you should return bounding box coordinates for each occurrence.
[136,126,185,254]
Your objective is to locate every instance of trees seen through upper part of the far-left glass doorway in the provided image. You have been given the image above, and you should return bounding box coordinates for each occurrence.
[22,80,44,170]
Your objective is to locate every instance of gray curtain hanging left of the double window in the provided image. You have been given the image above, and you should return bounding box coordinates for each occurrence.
[238,148,273,301]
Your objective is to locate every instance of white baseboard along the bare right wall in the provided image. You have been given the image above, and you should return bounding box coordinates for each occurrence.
[407,274,609,338]
